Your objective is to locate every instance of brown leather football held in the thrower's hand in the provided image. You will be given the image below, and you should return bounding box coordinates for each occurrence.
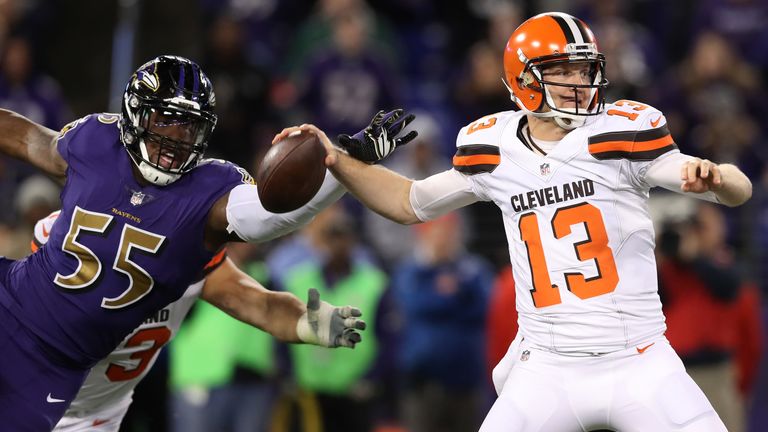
[256,132,326,213]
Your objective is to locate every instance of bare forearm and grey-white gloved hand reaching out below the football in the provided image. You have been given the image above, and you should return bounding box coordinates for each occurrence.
[201,258,365,348]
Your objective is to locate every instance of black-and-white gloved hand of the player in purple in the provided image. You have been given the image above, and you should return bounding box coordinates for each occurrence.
[338,109,419,163]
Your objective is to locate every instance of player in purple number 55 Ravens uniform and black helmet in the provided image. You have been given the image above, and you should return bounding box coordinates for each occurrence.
[0,56,410,431]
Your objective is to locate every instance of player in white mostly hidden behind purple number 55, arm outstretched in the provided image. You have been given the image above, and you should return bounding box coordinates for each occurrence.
[27,211,365,432]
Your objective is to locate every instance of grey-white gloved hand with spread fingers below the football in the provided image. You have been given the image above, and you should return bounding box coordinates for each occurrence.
[296,288,365,348]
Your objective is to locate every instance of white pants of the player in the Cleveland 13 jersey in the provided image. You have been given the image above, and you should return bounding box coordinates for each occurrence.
[480,334,727,432]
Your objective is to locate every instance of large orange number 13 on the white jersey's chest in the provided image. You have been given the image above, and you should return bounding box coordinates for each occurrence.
[519,203,619,308]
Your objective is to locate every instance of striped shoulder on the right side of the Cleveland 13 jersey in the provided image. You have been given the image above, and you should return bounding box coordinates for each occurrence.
[589,100,677,161]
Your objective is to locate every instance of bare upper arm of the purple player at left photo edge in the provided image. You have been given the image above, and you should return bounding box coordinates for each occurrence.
[0,109,67,182]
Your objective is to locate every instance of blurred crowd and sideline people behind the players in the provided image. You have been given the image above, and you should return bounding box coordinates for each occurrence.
[0,0,768,432]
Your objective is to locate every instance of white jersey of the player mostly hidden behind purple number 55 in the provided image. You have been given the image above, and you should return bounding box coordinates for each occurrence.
[32,211,216,426]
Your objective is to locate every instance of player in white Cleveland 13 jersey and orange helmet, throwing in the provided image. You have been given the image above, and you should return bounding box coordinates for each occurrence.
[274,13,752,432]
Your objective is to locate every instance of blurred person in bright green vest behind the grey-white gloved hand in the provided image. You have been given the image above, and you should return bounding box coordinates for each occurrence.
[276,206,391,432]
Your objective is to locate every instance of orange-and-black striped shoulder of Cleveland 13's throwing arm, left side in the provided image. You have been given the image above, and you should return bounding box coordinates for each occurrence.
[453,111,520,174]
